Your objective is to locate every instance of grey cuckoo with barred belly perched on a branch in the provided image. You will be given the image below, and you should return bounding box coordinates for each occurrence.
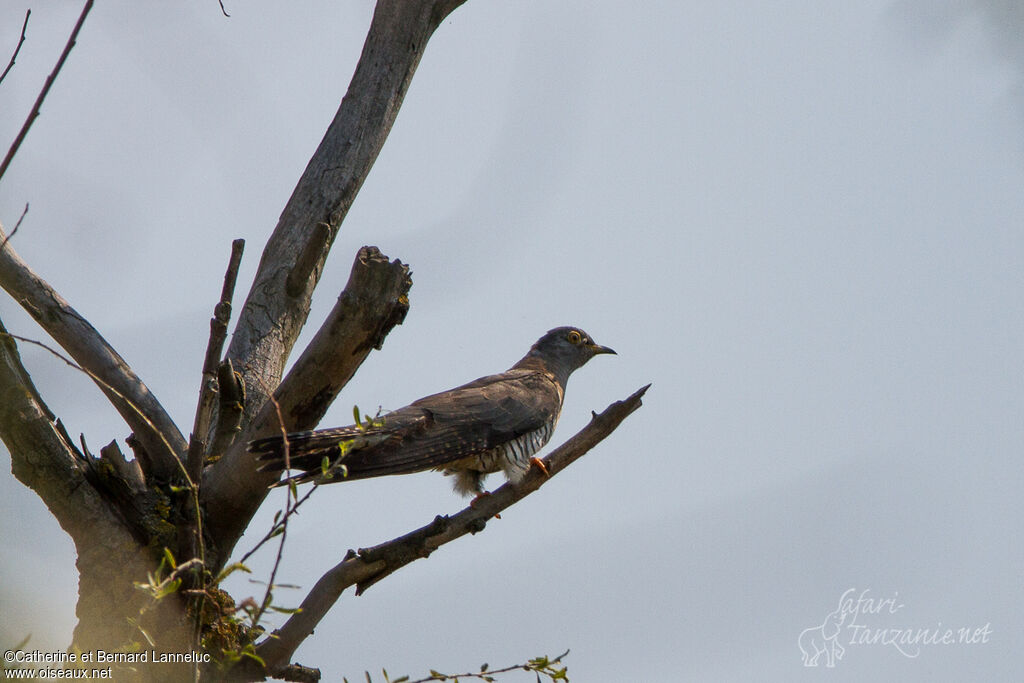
[249,328,614,495]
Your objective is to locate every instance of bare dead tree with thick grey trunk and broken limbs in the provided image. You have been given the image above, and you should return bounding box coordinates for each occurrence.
[0,0,646,680]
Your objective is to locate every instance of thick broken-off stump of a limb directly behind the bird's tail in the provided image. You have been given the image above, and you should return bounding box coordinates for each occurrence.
[203,247,412,568]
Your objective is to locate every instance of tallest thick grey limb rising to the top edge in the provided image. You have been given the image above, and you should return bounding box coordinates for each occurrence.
[227,0,464,446]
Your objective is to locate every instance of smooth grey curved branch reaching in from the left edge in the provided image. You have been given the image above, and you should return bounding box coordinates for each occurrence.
[0,222,185,479]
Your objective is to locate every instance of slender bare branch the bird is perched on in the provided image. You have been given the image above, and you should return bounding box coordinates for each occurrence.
[246,384,650,673]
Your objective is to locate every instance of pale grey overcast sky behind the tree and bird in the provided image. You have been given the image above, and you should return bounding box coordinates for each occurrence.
[0,0,1024,683]
